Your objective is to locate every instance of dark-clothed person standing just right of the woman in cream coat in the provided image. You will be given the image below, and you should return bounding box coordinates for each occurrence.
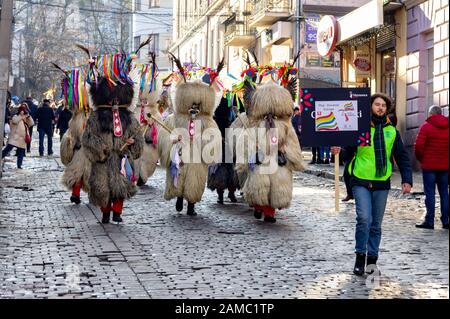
[36,99,55,156]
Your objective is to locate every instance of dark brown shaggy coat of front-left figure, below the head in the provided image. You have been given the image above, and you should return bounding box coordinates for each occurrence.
[82,108,143,207]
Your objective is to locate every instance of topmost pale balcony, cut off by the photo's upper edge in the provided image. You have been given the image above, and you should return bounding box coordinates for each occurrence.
[250,0,293,27]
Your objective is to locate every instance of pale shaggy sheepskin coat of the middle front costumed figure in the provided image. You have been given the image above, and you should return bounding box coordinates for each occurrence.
[158,81,222,203]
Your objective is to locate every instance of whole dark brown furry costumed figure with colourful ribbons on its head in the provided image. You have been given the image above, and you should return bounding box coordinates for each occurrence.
[81,43,146,223]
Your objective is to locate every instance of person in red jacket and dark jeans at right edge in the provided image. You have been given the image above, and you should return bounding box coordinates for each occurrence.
[414,105,449,229]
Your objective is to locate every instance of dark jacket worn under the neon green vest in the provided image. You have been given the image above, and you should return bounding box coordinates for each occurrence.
[344,130,413,190]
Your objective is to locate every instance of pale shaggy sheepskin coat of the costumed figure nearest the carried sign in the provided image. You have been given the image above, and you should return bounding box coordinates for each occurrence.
[243,82,304,209]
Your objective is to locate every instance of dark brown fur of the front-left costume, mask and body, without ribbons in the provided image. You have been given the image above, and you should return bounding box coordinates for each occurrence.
[82,77,143,214]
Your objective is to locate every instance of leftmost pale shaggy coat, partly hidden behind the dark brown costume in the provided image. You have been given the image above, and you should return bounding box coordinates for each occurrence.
[60,111,91,192]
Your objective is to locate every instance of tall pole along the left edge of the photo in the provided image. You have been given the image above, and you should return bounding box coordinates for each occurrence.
[0,0,13,178]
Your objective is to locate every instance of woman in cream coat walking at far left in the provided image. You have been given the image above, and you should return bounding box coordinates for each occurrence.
[2,103,34,169]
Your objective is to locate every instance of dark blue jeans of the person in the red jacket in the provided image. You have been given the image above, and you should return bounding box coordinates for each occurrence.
[422,169,448,225]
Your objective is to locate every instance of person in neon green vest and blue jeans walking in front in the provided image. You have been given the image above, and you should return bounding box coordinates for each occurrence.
[332,93,412,276]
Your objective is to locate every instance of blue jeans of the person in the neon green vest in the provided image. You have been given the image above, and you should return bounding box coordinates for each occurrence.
[352,186,389,257]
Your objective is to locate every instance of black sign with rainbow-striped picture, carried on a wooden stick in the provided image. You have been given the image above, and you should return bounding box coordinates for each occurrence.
[300,88,371,147]
